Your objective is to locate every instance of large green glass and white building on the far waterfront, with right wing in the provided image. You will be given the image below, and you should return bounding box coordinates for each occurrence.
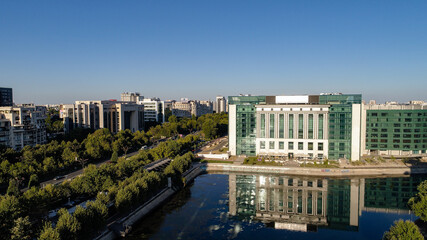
[229,94,427,160]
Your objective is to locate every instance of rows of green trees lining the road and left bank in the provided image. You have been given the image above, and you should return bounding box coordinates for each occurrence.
[0,114,228,239]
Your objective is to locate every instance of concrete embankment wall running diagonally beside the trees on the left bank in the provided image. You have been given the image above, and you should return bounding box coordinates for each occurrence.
[95,165,204,240]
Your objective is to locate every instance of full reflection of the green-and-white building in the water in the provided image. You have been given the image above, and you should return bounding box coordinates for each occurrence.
[229,174,423,231]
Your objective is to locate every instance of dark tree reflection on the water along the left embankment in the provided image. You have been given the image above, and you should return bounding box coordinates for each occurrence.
[126,183,193,239]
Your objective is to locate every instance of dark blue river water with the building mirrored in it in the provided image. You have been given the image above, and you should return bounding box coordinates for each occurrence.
[126,174,426,240]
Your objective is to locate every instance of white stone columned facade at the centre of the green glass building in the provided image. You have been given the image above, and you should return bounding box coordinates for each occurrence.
[256,105,329,159]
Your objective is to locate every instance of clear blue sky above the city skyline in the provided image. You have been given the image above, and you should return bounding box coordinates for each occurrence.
[0,0,427,104]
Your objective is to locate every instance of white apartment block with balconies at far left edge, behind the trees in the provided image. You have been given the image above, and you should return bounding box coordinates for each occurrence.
[0,104,46,150]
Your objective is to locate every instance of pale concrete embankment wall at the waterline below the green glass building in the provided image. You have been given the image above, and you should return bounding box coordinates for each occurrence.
[206,163,427,177]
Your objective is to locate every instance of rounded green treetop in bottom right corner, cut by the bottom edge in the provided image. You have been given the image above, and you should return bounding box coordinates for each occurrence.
[383,219,424,240]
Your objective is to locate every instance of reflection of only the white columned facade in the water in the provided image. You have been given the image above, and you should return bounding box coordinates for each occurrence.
[256,176,328,231]
